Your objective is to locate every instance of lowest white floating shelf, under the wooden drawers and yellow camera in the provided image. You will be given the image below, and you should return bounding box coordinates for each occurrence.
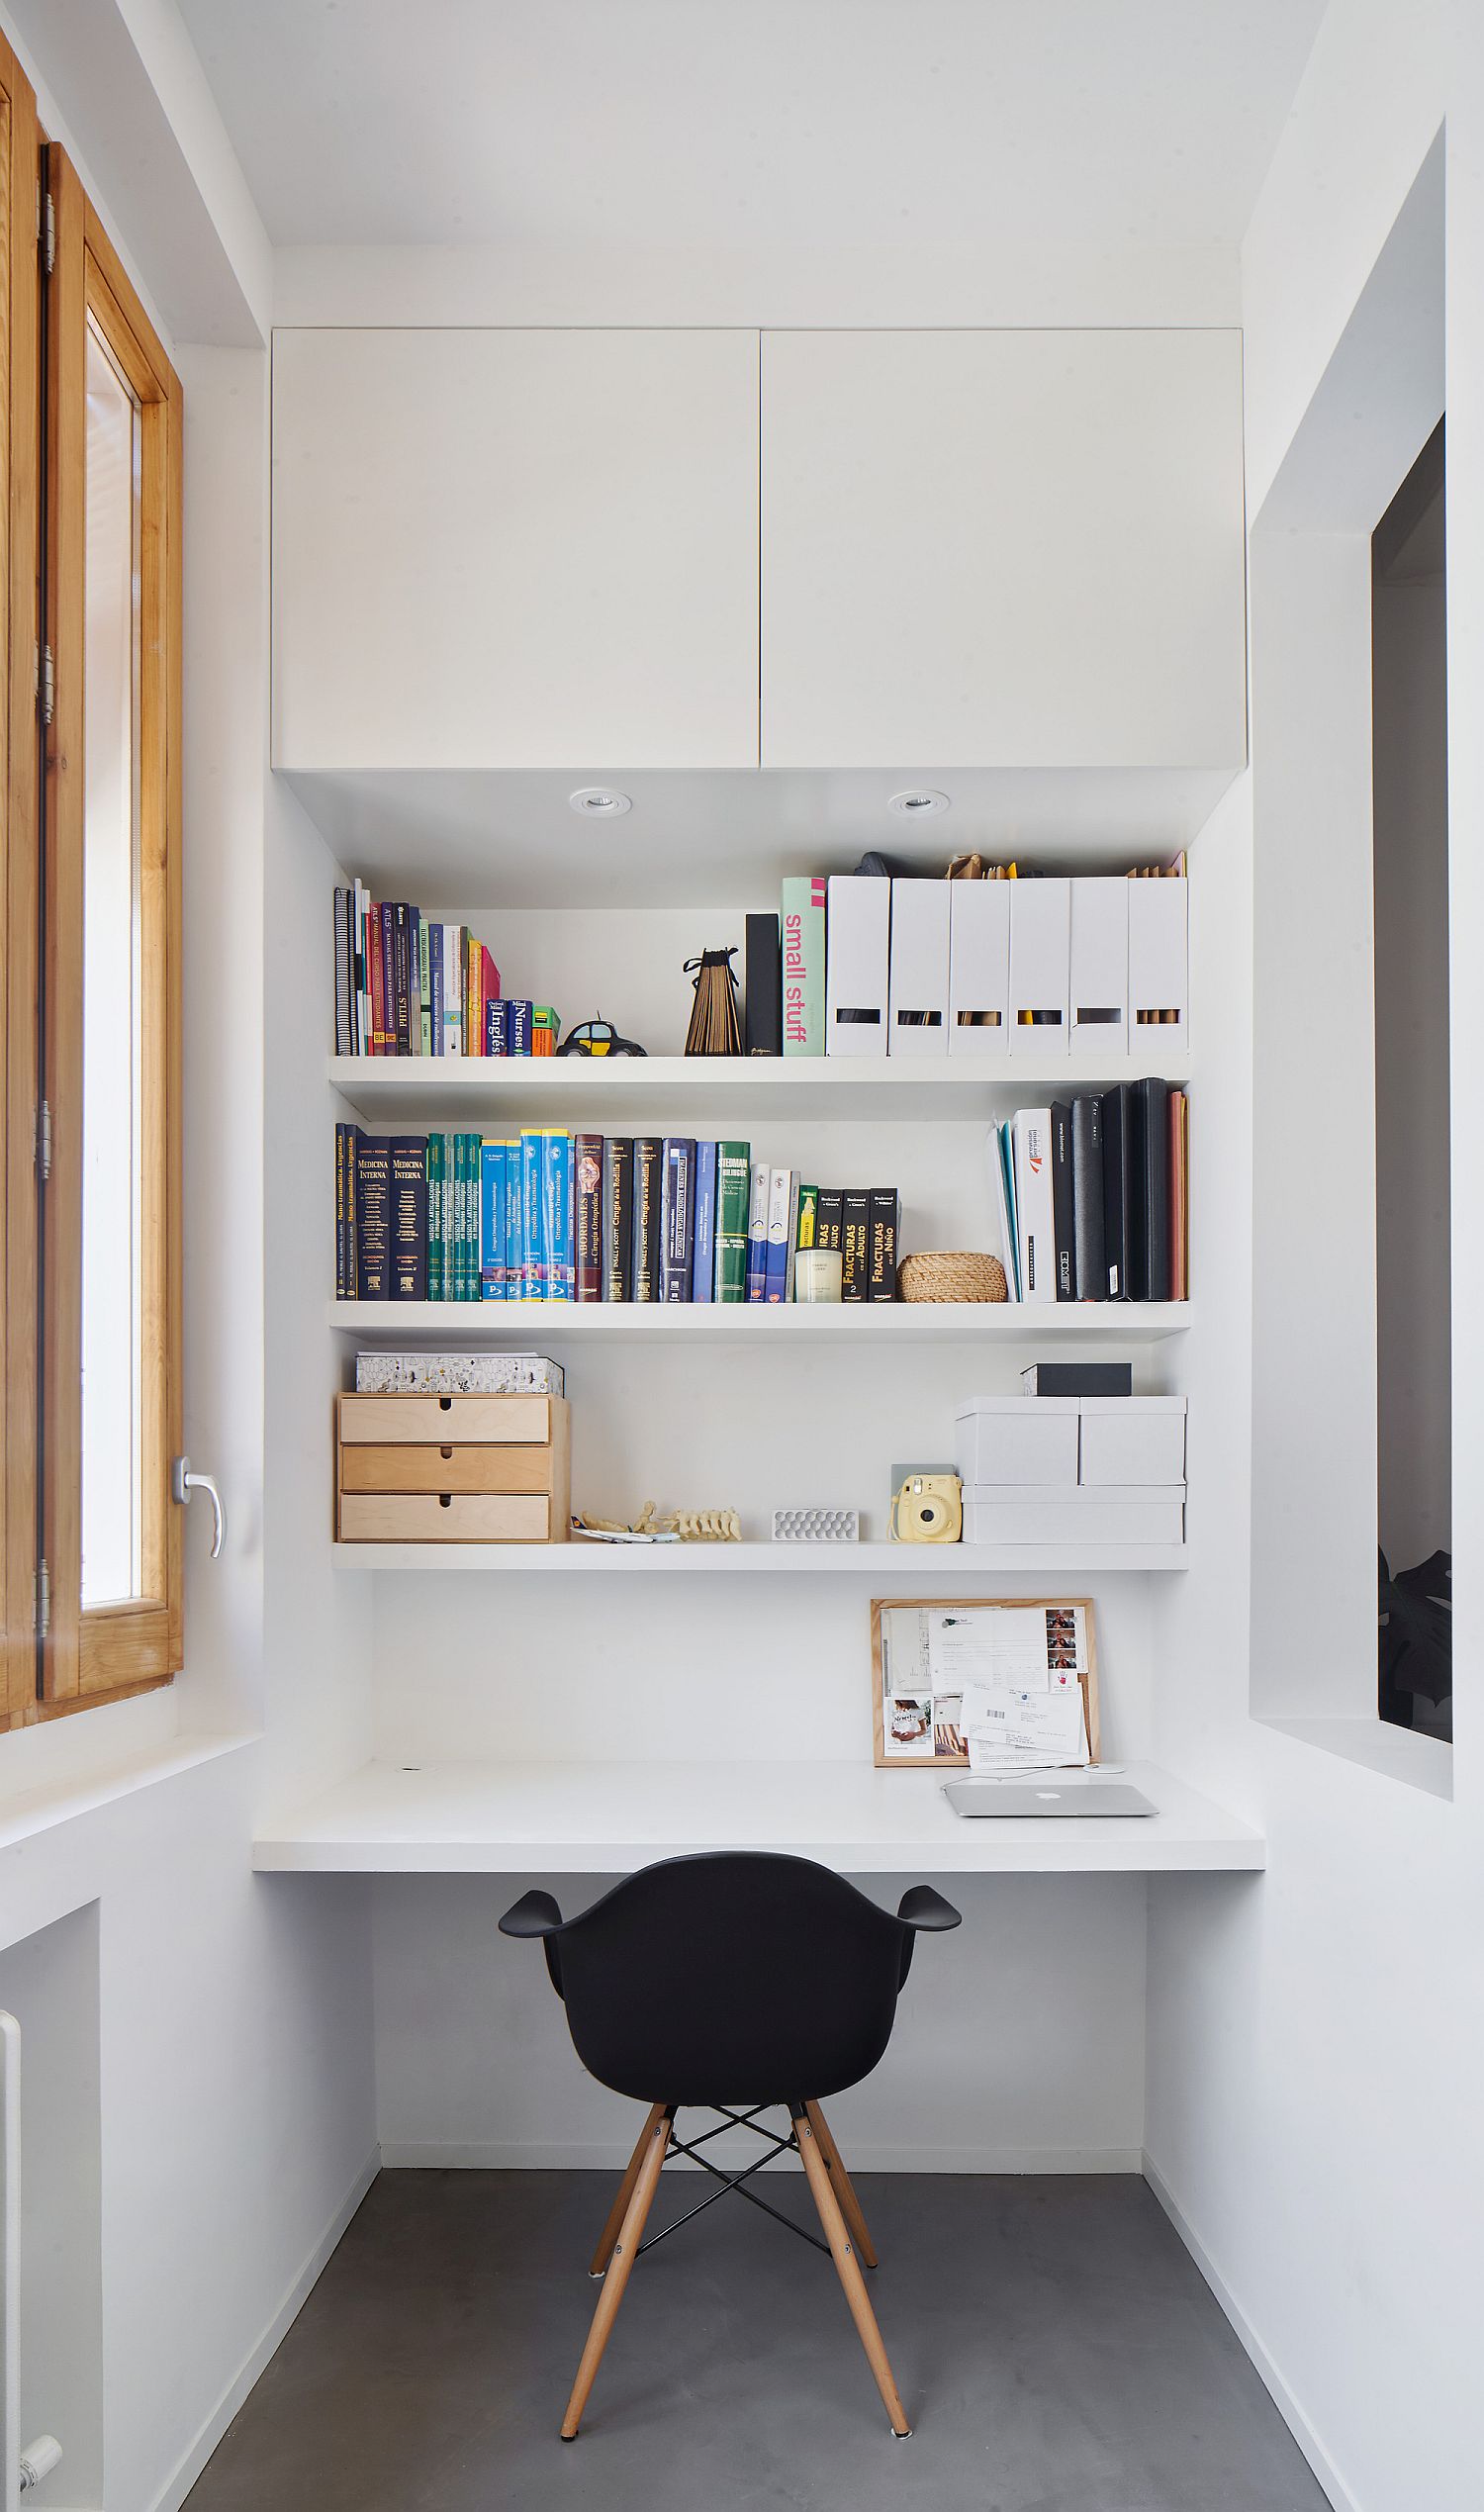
[331,1535,1185,1585]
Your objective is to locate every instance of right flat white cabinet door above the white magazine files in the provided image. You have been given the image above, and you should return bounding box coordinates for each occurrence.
[761,331,1246,769]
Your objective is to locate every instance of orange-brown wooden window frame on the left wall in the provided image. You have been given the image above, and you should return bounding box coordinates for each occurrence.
[0,78,183,1728]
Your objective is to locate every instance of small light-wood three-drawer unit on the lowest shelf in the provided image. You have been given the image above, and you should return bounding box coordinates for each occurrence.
[334,1397,573,1544]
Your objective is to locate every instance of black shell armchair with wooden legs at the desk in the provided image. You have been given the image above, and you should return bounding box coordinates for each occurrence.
[500,1854,960,2442]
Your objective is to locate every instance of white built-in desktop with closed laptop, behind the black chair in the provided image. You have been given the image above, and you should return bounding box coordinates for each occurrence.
[253,1761,1265,1877]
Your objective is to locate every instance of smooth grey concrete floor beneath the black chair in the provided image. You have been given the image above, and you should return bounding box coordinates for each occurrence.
[186,2158,1324,2512]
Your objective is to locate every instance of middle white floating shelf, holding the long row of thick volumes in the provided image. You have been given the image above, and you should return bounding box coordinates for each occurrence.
[328,1299,1190,1351]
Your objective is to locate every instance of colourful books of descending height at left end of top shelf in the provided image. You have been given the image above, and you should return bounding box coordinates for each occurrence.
[334,882,560,1055]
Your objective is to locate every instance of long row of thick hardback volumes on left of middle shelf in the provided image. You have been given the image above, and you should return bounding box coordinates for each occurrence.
[334,1125,901,1306]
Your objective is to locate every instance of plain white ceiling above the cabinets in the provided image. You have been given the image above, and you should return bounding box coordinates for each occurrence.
[178,0,1324,253]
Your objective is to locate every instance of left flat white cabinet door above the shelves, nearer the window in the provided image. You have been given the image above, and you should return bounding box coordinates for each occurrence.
[274,331,758,771]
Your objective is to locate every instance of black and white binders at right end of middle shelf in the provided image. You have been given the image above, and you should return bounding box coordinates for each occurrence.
[986,1077,1190,1301]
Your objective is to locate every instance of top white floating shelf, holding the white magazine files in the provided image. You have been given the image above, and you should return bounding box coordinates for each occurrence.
[328,1030,1190,1131]
